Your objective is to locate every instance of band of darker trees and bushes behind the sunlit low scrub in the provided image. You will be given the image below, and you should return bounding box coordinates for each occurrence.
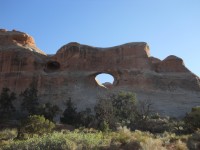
[0,86,200,134]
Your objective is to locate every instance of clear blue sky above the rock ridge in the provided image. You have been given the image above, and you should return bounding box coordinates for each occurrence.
[0,0,200,82]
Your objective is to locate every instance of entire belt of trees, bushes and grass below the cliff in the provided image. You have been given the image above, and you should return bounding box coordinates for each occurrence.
[0,85,200,150]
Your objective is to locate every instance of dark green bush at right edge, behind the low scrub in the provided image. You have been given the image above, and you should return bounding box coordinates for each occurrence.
[184,106,200,132]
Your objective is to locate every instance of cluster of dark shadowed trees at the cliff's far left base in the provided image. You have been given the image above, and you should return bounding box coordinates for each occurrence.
[0,82,60,122]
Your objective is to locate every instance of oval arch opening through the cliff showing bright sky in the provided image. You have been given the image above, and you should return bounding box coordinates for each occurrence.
[95,73,115,89]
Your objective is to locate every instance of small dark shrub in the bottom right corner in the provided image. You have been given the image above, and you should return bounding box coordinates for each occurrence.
[187,130,200,150]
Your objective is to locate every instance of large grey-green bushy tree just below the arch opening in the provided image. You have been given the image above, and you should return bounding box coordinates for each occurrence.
[94,92,136,129]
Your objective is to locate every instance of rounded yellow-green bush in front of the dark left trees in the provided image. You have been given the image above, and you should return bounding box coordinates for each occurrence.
[18,115,55,138]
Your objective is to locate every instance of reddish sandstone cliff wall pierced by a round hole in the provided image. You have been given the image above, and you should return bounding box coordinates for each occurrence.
[0,30,200,117]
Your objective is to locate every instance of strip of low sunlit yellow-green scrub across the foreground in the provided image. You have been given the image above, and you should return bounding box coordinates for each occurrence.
[0,127,194,150]
